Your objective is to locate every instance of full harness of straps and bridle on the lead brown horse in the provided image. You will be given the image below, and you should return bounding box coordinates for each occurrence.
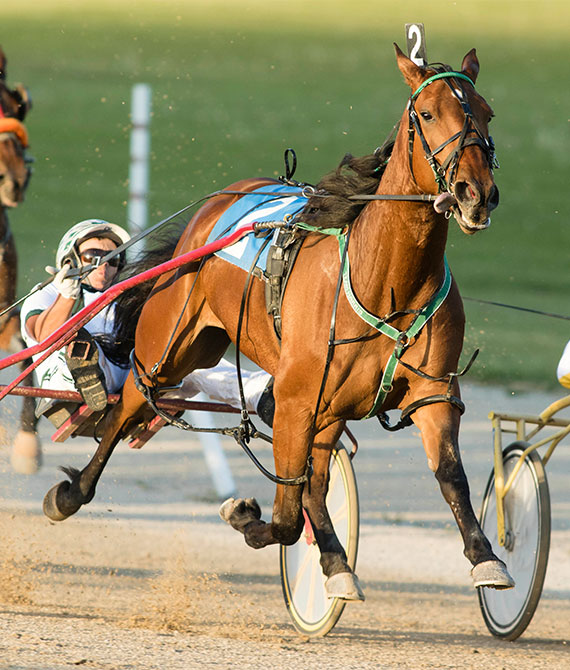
[125,71,498,485]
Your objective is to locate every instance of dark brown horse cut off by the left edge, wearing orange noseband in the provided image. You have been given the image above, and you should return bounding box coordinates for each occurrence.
[0,48,41,474]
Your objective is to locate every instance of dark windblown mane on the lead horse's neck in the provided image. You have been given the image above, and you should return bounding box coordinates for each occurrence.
[297,141,394,228]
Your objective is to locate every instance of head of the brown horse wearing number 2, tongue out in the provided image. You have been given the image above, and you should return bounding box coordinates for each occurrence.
[395,45,499,234]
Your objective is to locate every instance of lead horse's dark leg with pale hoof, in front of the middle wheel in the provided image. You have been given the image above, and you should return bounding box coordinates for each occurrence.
[303,422,364,600]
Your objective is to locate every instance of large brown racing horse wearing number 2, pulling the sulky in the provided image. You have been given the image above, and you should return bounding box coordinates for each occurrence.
[44,46,513,599]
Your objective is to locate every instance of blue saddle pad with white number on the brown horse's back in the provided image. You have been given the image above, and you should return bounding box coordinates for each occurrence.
[208,184,307,272]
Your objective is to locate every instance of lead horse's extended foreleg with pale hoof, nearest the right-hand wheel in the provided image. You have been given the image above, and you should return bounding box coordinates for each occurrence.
[413,403,514,589]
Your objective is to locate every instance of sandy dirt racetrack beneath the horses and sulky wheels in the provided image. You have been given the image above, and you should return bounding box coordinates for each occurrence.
[0,389,570,670]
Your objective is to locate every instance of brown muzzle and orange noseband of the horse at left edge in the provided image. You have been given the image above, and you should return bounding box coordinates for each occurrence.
[0,129,30,207]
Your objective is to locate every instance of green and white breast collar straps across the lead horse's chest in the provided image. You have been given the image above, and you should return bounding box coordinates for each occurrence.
[296,222,451,419]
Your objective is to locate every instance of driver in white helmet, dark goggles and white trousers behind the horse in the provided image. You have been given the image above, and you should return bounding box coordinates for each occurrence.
[16,219,275,472]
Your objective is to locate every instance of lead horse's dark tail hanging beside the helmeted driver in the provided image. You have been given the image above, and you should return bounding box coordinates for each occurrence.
[97,224,185,368]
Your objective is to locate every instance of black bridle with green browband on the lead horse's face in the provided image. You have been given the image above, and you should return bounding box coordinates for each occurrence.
[407,71,499,193]
